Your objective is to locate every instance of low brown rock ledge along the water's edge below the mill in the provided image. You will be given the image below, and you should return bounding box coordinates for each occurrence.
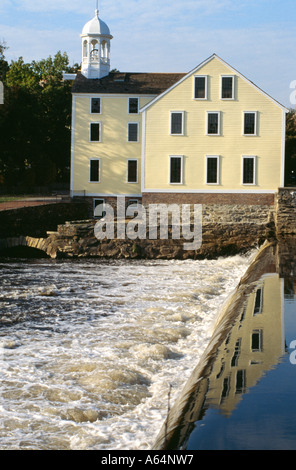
[10,215,270,259]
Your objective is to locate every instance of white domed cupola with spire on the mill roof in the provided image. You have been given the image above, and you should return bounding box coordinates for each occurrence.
[80,9,113,78]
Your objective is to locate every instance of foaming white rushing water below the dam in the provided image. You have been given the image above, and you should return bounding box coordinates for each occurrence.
[0,256,254,450]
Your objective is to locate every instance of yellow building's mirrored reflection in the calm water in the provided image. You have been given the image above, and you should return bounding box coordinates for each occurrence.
[204,274,285,415]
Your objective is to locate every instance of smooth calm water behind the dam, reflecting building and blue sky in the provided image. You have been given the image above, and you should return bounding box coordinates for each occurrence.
[155,240,296,450]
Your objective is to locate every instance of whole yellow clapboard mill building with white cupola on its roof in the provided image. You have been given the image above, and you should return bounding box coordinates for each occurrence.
[66,10,288,215]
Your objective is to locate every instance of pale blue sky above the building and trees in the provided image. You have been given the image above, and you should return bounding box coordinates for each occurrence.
[0,0,296,107]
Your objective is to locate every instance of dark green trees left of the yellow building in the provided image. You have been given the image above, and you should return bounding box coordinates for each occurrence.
[0,43,78,192]
